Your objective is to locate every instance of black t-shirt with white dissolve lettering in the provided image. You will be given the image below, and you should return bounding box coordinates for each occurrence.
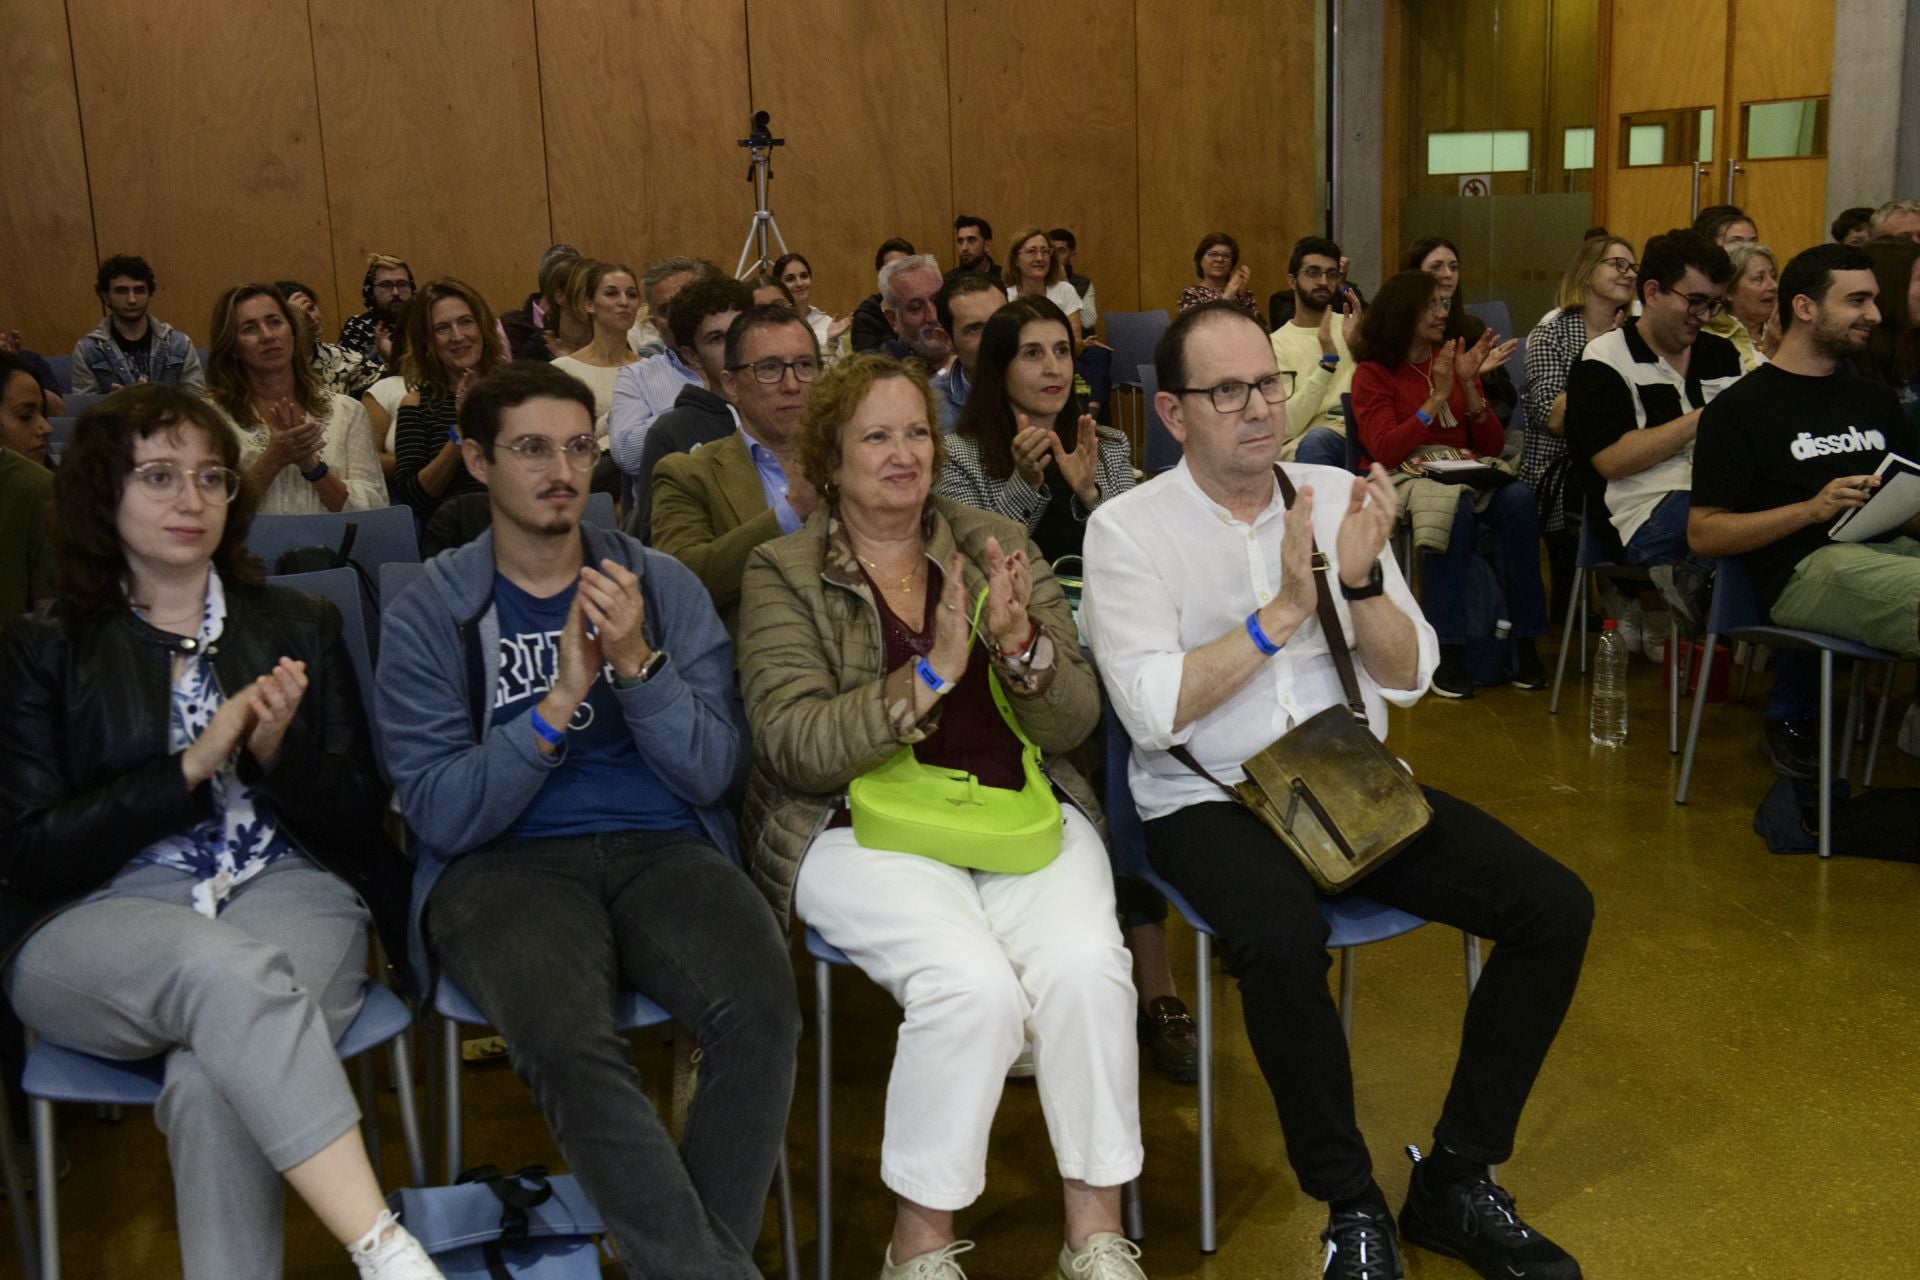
[1693,365,1920,608]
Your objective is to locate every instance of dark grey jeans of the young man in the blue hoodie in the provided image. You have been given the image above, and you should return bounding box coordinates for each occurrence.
[426,831,801,1280]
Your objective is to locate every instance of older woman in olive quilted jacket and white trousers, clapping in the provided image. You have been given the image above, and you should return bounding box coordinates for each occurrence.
[739,353,1144,1280]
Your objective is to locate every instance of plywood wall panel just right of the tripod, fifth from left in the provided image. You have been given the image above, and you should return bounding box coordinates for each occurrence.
[741,0,952,315]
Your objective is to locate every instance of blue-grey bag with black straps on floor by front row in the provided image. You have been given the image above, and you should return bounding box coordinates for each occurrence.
[386,1165,607,1280]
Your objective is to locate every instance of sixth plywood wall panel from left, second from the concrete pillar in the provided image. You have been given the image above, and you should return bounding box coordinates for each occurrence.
[943,0,1140,311]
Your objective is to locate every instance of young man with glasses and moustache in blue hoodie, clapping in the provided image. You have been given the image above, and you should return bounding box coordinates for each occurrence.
[378,363,801,1280]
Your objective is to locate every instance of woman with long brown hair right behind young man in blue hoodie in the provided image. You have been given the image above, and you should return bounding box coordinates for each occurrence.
[392,276,501,520]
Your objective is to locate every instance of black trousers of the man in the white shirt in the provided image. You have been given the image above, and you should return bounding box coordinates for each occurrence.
[1146,789,1594,1199]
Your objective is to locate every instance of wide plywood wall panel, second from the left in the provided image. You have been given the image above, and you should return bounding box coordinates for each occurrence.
[63,0,338,355]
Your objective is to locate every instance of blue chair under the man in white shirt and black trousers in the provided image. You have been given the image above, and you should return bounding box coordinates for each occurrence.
[1102,699,1480,1253]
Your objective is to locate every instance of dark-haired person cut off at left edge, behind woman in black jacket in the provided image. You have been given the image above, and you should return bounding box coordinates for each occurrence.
[0,351,54,635]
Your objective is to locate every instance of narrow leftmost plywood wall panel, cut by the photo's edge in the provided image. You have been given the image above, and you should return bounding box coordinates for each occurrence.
[0,0,100,355]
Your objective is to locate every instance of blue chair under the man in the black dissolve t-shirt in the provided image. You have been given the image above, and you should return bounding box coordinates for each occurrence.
[1674,557,1899,844]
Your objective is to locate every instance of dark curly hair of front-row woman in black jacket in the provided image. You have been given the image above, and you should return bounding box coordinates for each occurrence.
[54,382,267,616]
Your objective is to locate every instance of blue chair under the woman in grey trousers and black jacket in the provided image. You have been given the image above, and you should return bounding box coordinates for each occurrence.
[21,983,426,1280]
